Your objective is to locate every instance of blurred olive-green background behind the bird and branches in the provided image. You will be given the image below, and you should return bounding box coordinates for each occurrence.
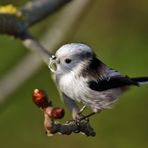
[0,0,148,148]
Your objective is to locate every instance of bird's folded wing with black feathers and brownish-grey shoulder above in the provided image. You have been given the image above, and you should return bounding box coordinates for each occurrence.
[87,58,138,91]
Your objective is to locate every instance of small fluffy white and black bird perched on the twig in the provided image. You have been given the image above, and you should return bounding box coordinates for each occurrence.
[49,43,148,118]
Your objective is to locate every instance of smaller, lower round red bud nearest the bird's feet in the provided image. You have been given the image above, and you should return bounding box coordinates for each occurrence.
[51,107,65,119]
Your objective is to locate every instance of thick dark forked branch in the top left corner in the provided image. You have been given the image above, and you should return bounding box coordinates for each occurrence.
[0,0,71,38]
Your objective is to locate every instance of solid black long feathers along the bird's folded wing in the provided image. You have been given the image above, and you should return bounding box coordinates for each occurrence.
[88,76,138,91]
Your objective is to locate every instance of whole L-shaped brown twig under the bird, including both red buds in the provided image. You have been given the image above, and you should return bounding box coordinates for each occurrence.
[33,89,95,136]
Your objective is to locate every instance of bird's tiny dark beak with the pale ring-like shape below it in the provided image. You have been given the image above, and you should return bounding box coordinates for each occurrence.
[48,55,57,73]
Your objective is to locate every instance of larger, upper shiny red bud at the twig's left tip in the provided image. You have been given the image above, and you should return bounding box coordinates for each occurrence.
[32,89,51,108]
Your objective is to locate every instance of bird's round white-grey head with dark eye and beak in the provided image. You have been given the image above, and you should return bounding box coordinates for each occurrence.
[49,43,94,75]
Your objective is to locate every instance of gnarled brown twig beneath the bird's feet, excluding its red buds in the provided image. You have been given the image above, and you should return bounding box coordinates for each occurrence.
[44,113,96,137]
